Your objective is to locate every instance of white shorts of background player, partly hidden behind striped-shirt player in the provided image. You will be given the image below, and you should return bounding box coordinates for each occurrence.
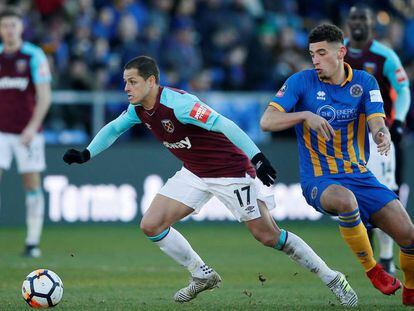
[367,133,398,190]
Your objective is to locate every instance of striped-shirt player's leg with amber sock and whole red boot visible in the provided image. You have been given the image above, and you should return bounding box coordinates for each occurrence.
[320,184,401,295]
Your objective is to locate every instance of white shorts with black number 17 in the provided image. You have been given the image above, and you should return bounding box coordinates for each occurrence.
[158,167,275,222]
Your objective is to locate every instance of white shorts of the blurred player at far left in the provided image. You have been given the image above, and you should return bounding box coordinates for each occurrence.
[0,132,46,174]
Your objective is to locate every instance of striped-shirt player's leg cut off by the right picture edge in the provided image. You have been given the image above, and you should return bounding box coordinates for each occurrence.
[371,200,414,305]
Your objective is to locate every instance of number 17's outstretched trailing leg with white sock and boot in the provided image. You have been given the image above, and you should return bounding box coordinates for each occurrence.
[245,200,358,307]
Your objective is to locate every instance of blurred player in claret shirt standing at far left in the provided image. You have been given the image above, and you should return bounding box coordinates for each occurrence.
[0,8,51,257]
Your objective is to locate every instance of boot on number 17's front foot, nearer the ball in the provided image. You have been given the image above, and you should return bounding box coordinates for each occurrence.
[174,270,221,302]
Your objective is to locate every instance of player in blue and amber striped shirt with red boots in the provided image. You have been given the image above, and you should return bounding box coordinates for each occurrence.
[260,24,414,305]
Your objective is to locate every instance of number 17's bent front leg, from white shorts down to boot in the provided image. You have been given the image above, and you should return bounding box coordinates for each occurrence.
[141,169,221,302]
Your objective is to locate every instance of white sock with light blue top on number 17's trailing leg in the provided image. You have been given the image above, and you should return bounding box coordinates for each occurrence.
[275,229,338,285]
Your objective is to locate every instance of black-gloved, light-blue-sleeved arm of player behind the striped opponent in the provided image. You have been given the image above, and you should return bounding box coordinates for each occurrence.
[383,50,411,143]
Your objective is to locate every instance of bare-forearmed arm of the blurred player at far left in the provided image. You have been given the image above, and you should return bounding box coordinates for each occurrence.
[20,49,52,145]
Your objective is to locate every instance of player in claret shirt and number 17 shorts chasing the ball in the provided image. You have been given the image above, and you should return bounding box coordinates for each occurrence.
[63,56,358,306]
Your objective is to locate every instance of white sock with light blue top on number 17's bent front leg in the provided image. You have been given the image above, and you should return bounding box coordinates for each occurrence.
[148,227,213,278]
